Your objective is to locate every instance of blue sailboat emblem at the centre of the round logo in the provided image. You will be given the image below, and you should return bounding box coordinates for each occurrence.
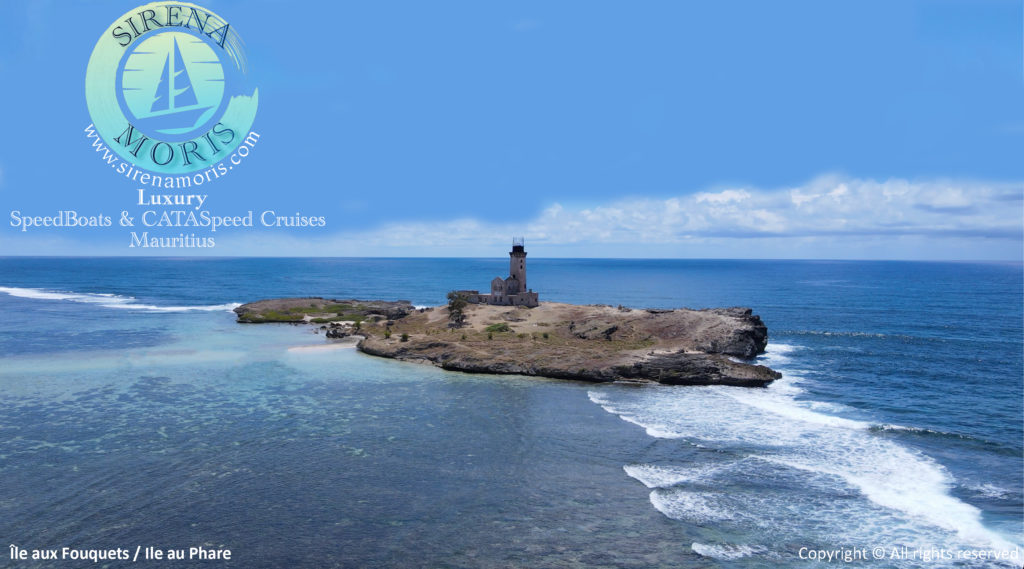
[135,38,211,131]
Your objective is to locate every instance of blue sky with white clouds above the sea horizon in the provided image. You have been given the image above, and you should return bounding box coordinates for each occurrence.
[0,0,1024,260]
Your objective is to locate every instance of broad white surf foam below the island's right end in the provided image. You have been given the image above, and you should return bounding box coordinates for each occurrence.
[590,346,1020,557]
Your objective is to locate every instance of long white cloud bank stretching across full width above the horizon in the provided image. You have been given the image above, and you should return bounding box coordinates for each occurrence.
[11,176,1024,261]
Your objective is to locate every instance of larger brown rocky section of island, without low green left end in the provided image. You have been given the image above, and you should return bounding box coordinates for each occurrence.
[358,303,781,387]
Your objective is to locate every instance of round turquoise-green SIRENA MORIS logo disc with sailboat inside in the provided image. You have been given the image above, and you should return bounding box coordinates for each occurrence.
[85,2,259,173]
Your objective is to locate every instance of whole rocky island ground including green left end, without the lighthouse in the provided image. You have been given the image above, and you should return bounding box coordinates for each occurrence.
[234,298,781,387]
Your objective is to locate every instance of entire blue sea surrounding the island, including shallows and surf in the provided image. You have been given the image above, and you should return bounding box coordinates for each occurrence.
[0,258,1024,568]
